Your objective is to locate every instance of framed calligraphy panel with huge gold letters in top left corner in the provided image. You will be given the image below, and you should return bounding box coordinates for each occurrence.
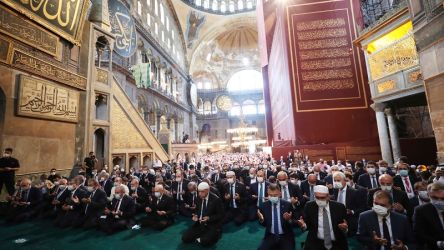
[0,0,89,45]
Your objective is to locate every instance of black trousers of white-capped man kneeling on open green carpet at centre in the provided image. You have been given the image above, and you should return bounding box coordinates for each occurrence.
[182,223,222,246]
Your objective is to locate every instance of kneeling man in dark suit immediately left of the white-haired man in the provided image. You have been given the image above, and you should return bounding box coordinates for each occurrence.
[73,179,108,229]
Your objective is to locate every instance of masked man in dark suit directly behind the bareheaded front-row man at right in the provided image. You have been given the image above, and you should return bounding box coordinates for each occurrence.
[367,174,413,218]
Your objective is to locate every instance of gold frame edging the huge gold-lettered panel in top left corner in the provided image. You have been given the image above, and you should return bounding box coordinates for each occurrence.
[0,0,89,46]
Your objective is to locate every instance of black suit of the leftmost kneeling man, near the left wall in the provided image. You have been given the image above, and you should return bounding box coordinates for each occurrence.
[6,187,43,223]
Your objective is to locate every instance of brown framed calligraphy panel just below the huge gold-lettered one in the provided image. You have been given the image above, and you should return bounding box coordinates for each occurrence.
[0,6,59,56]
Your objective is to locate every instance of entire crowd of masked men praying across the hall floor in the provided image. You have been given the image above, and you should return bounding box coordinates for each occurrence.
[0,149,444,250]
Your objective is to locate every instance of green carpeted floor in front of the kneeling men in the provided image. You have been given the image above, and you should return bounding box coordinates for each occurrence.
[0,217,360,250]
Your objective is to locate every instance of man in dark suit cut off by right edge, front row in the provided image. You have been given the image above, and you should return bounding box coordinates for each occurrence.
[413,182,444,250]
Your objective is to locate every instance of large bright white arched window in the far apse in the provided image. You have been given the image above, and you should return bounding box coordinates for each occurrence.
[227,70,263,91]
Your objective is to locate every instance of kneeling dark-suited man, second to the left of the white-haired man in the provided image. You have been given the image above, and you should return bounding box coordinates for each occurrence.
[54,176,88,227]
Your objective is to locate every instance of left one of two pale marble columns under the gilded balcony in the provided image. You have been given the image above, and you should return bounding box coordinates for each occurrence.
[370,103,393,165]
